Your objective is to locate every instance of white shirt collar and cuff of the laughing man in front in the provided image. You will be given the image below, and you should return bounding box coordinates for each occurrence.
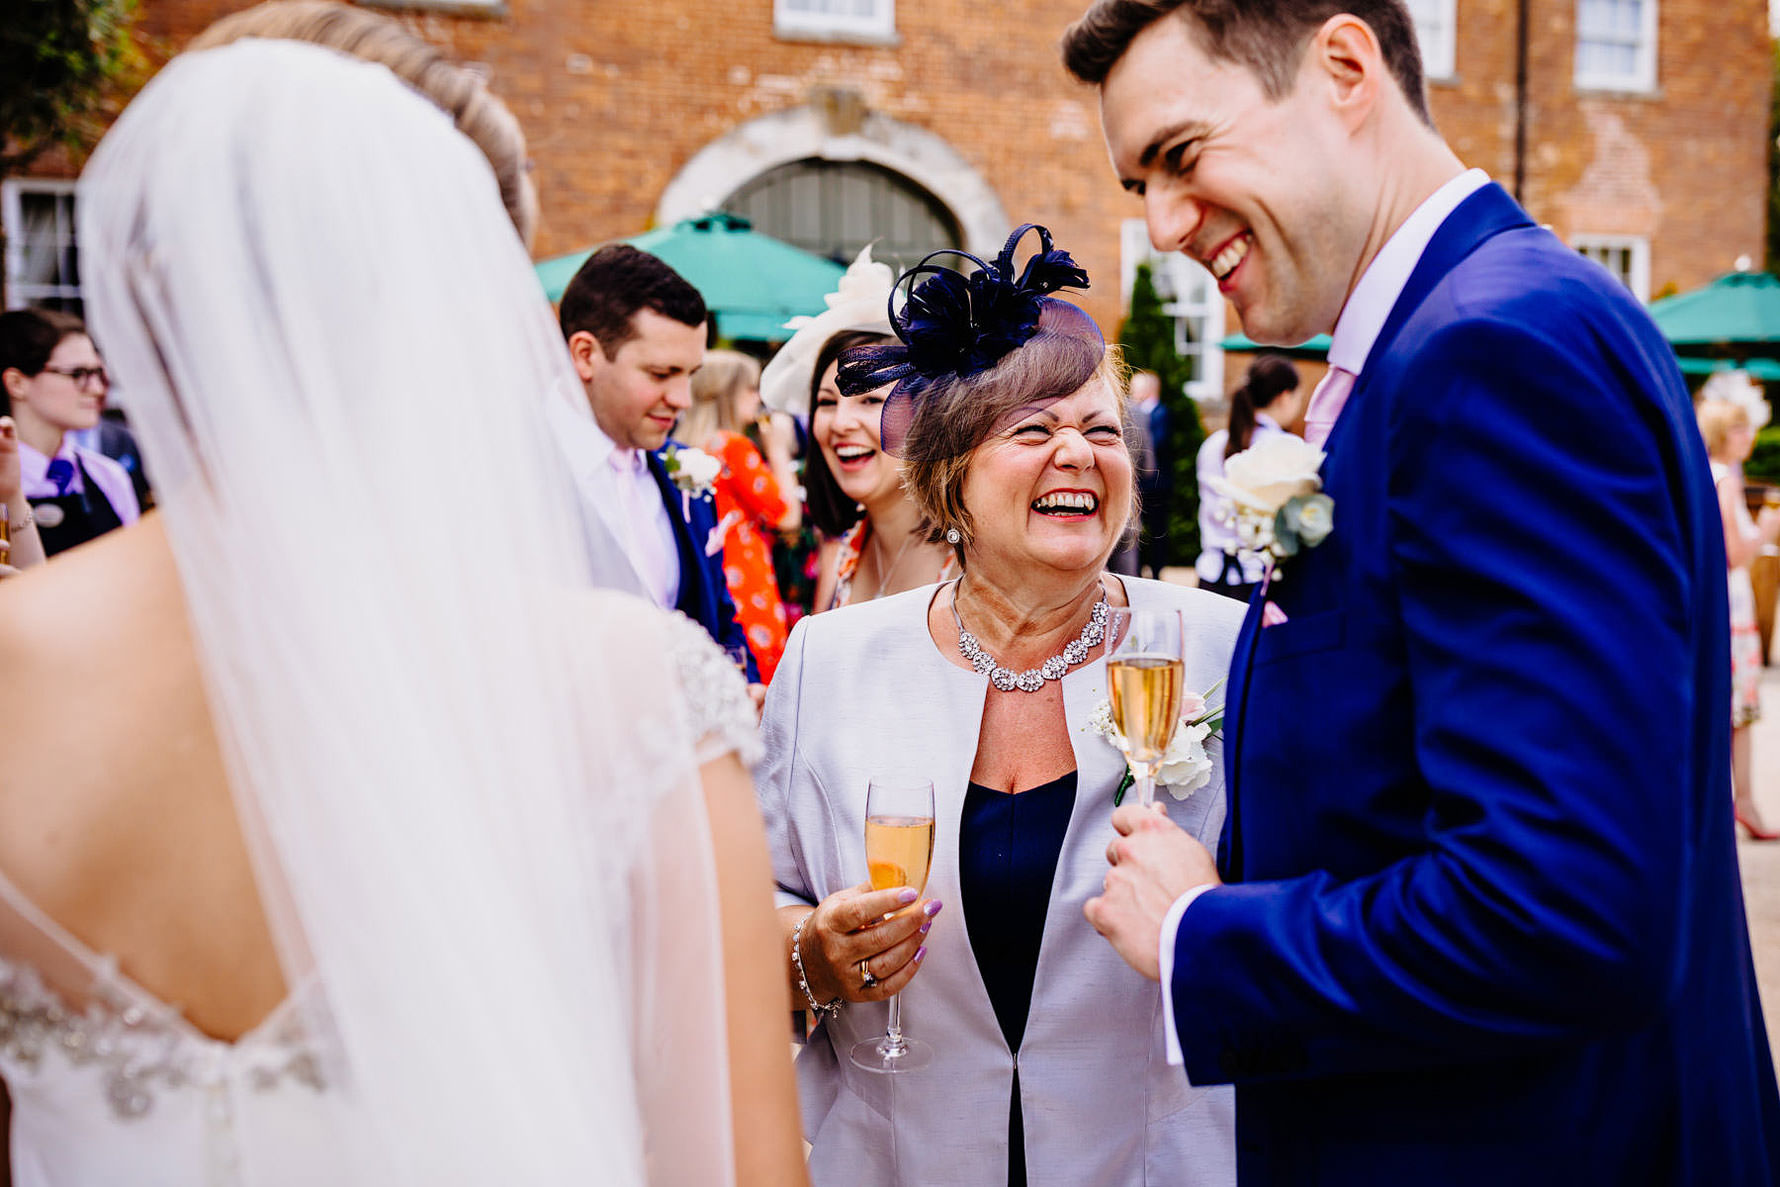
[1157,169,1490,1064]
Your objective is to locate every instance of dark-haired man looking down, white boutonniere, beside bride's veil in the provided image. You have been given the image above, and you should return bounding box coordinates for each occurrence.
[552,244,760,685]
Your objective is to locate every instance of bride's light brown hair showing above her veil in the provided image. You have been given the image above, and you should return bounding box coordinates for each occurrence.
[185,0,538,247]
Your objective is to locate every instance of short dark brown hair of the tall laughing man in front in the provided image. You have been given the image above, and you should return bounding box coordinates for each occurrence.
[1063,0,1435,126]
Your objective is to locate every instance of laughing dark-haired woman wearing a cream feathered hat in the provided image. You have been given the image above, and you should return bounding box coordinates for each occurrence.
[760,247,958,612]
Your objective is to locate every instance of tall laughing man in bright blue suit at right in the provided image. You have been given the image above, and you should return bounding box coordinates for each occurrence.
[1064,0,1780,1187]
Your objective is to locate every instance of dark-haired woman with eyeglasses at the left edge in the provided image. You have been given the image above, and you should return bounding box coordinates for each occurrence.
[0,310,141,557]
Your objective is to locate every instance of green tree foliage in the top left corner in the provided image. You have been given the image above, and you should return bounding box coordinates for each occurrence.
[0,0,148,176]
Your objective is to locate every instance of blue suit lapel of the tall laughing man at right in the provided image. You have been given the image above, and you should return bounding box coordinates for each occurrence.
[1218,182,1534,881]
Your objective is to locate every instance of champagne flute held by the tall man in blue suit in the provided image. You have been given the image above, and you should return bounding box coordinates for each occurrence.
[1107,607,1185,808]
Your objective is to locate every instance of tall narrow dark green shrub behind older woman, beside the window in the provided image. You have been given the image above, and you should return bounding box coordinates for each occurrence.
[1118,263,1205,564]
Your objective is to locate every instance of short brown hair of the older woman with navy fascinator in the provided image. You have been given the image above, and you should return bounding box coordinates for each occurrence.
[902,348,1129,564]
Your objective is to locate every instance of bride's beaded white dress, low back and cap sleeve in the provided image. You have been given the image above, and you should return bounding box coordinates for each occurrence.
[0,618,758,1187]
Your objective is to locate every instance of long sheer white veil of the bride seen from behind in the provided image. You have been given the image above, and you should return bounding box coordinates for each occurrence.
[80,41,732,1183]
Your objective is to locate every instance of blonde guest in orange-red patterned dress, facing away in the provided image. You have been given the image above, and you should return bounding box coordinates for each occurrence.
[678,351,803,683]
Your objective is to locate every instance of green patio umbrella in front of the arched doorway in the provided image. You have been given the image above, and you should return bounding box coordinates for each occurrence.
[538,212,846,342]
